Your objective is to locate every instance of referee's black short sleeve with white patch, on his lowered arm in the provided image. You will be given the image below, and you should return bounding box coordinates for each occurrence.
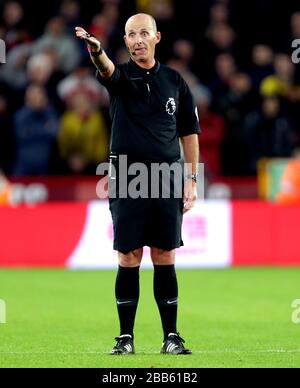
[177,76,201,137]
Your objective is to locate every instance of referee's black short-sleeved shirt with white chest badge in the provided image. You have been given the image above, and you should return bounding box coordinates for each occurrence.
[98,60,200,163]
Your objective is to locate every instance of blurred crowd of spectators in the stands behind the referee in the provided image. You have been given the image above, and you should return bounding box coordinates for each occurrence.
[0,0,300,178]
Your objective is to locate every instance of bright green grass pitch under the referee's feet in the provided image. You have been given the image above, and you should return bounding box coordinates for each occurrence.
[0,268,300,368]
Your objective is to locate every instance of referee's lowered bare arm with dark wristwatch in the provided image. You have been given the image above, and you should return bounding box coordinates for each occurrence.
[181,134,200,214]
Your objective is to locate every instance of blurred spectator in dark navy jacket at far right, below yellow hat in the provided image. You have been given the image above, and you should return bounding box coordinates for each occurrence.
[244,97,294,174]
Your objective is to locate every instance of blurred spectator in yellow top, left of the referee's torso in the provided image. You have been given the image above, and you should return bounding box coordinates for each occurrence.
[58,91,108,174]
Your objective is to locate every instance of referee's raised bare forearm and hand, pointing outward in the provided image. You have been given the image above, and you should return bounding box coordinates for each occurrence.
[75,27,115,78]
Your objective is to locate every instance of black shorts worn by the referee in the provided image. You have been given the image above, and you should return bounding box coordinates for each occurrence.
[109,158,183,254]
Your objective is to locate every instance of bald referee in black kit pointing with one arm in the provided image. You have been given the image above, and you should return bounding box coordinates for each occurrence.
[76,14,200,355]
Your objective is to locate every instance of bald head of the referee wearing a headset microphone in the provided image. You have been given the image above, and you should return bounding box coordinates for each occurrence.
[124,15,161,62]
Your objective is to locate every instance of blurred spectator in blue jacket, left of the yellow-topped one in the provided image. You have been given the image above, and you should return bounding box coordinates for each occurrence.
[13,85,58,176]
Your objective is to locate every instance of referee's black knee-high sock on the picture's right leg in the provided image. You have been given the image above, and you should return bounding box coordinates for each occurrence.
[154,265,178,340]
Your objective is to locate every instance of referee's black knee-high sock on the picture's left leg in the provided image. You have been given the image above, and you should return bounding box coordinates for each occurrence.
[116,267,140,337]
